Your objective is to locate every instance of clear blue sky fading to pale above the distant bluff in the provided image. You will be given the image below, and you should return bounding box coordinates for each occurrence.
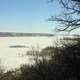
[0,0,61,33]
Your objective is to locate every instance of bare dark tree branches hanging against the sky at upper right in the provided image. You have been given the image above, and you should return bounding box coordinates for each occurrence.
[49,0,80,31]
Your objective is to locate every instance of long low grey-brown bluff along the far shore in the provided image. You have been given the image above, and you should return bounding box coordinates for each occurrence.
[0,32,54,37]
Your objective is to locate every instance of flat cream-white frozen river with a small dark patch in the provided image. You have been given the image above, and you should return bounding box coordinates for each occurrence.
[0,37,55,69]
